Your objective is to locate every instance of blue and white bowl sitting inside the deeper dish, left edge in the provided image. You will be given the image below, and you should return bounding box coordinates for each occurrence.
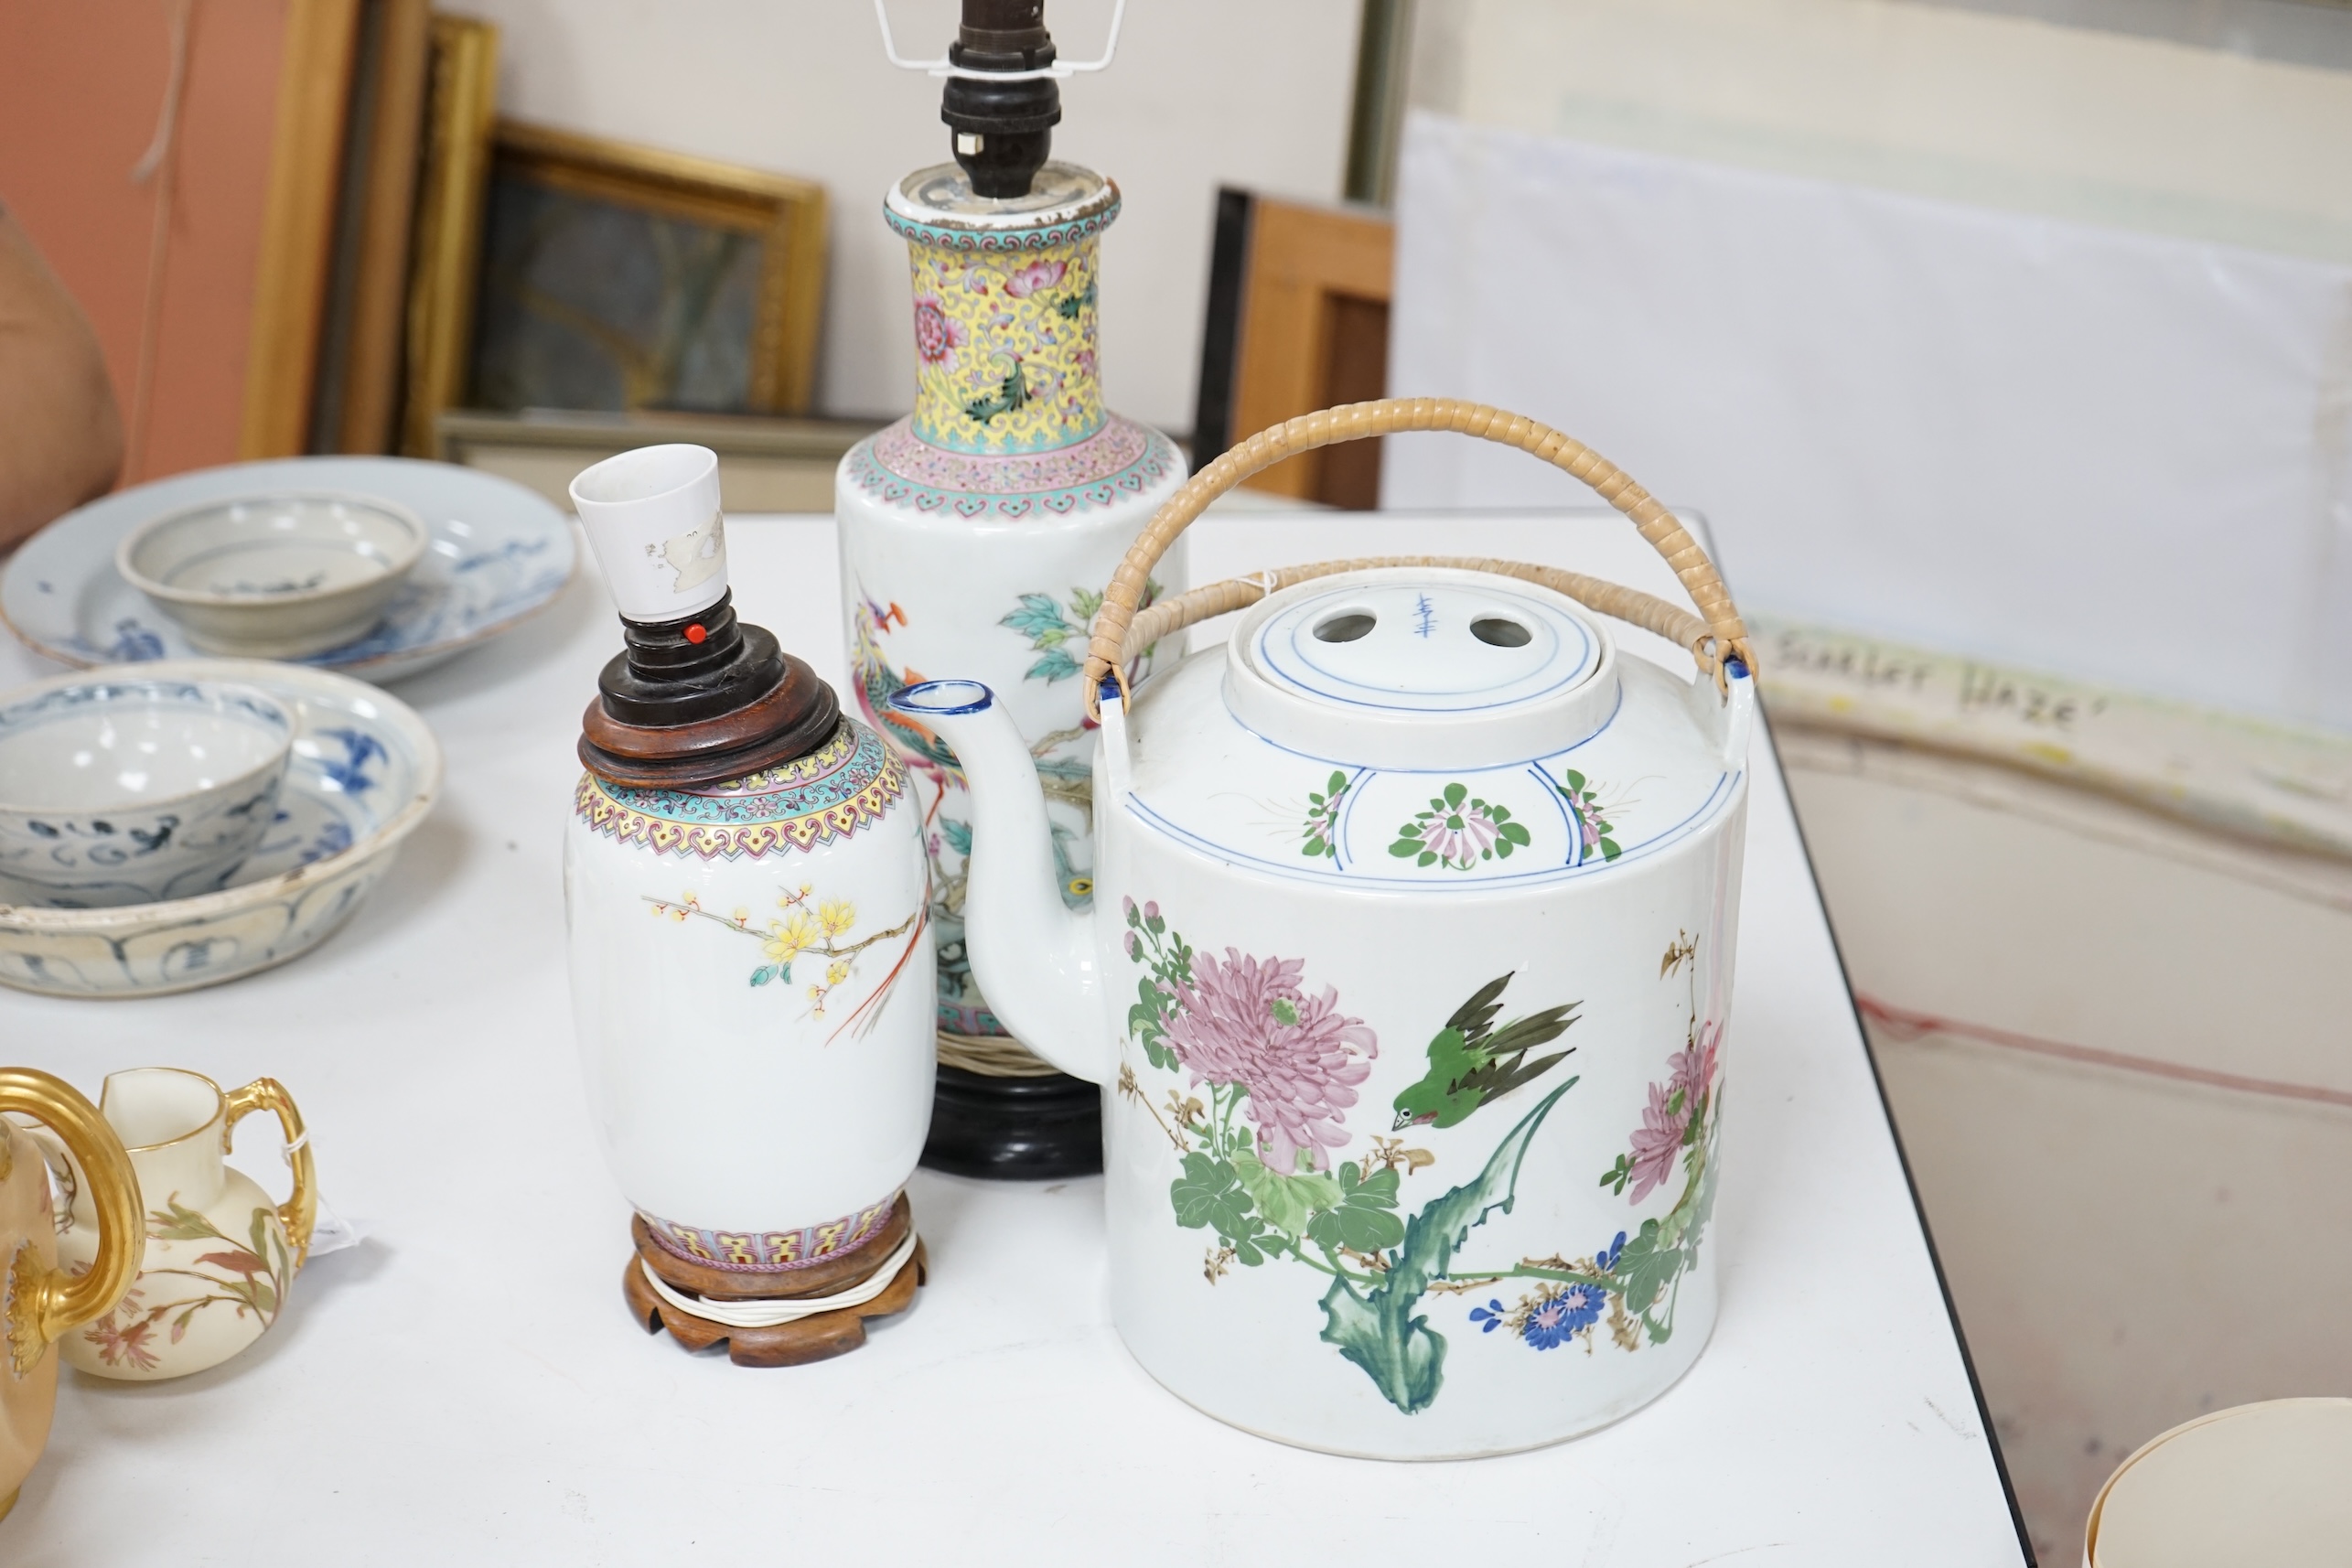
[0,670,294,909]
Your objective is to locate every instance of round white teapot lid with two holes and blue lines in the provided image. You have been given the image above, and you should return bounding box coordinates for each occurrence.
[1225,566,1618,768]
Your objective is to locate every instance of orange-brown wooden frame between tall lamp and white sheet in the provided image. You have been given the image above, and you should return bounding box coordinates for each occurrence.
[1192,190,1395,508]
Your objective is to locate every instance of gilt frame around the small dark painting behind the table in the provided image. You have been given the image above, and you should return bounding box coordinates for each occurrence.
[475,123,825,413]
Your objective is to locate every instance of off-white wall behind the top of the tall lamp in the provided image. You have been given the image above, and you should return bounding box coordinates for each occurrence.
[449,0,1359,433]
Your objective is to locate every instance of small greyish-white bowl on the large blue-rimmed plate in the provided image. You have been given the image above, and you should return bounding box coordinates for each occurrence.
[115,491,428,659]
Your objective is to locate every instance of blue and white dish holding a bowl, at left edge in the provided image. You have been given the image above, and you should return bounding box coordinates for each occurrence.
[0,659,442,997]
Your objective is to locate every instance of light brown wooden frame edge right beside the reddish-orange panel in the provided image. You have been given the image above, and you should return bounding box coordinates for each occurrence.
[238,0,360,458]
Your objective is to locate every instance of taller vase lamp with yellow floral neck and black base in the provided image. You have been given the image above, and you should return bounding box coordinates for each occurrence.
[835,0,1183,1177]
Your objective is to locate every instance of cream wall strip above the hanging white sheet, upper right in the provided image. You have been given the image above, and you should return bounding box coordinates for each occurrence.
[1412,0,2352,261]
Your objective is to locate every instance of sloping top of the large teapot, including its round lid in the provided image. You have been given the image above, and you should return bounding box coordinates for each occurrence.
[1119,566,1755,893]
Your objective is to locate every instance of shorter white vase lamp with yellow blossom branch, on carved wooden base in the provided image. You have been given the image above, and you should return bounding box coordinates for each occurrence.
[564,446,934,1366]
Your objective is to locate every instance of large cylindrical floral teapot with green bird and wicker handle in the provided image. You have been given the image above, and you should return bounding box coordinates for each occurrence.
[897,400,1755,1457]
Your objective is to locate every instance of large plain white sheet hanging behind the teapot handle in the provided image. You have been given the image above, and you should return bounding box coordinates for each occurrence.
[1383,113,2352,729]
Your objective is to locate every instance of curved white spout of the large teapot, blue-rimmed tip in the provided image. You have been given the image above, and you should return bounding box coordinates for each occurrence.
[889,680,1112,1084]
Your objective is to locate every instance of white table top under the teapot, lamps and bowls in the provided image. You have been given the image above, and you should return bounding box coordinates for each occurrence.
[0,512,2032,1568]
